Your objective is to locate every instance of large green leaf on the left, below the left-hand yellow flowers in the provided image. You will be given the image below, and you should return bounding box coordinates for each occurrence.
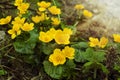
[13,30,38,54]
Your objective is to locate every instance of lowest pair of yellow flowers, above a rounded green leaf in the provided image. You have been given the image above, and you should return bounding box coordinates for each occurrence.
[49,46,75,66]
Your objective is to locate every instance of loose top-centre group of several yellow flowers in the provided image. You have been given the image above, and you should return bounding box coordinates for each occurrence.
[32,1,61,26]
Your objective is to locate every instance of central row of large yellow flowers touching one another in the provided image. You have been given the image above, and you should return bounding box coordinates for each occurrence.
[39,28,72,44]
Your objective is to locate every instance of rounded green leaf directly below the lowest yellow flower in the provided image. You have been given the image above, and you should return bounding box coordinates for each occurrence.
[43,61,64,79]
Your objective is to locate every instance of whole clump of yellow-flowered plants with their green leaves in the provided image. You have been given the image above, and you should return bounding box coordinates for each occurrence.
[0,0,120,80]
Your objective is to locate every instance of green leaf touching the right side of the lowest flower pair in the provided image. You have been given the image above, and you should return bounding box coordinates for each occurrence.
[75,49,86,62]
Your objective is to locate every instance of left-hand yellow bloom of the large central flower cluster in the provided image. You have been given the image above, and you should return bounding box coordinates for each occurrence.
[39,28,56,43]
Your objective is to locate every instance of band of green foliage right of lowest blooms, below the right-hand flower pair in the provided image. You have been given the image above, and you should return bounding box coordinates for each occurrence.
[75,48,105,62]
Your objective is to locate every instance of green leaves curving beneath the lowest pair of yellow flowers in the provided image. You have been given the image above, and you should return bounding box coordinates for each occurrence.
[43,60,76,79]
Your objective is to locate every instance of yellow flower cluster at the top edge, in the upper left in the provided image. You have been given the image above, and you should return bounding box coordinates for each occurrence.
[14,0,30,15]
